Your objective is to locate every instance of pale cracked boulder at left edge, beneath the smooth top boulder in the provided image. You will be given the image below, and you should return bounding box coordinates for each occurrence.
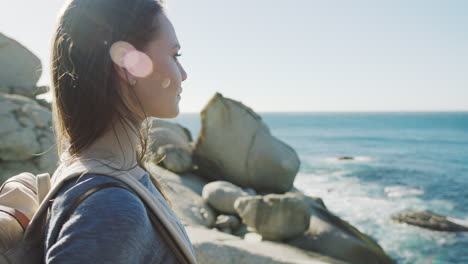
[0,93,58,182]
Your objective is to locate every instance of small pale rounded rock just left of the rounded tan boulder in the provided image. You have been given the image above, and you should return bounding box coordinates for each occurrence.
[202,181,248,214]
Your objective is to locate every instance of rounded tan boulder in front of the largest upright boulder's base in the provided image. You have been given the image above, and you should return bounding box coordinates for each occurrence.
[234,193,310,240]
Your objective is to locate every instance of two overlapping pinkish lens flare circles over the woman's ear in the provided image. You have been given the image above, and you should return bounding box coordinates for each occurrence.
[109,41,153,77]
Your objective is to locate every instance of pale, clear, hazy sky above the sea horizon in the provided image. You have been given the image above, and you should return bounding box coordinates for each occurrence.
[0,0,468,112]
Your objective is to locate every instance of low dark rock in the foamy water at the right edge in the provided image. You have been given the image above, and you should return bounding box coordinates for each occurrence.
[392,211,468,232]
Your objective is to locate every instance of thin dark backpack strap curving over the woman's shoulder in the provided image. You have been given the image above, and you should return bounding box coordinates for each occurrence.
[52,178,190,264]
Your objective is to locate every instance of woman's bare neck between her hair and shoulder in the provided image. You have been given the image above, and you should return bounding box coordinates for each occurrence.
[79,118,138,169]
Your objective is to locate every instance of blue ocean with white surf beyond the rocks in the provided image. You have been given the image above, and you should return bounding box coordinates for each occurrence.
[173,112,468,264]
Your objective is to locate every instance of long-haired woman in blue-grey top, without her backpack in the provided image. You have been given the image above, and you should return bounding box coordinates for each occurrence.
[44,0,193,264]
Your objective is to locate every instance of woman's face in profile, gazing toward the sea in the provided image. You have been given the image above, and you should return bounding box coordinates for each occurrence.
[121,13,187,118]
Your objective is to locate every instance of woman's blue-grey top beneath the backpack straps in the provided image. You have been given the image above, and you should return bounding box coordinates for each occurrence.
[44,173,193,264]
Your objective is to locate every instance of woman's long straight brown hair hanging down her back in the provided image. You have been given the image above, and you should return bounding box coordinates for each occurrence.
[51,0,168,200]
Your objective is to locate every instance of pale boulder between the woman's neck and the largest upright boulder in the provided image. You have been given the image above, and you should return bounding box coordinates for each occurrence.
[148,118,194,173]
